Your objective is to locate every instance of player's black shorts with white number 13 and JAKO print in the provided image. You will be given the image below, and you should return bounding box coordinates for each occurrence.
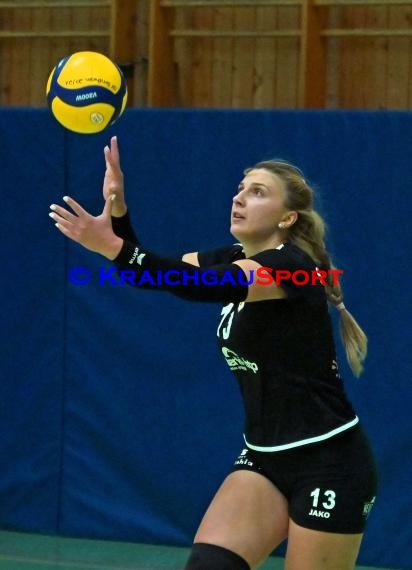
[233,426,377,534]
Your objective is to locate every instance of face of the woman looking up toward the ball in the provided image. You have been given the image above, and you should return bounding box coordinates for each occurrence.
[230,168,288,242]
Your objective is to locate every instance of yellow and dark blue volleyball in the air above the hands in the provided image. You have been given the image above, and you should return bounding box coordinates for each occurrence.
[46,51,127,134]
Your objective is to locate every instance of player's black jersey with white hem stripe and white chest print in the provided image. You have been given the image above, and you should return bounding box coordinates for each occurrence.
[198,243,359,452]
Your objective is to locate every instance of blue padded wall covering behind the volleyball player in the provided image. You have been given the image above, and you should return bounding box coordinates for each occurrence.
[0,109,412,569]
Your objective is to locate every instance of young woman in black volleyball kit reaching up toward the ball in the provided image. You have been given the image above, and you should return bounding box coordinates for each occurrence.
[50,137,376,570]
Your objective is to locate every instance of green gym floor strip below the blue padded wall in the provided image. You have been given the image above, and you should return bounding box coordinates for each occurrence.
[0,531,396,570]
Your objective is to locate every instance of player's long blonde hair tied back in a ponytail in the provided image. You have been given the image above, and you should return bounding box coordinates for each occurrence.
[251,160,368,377]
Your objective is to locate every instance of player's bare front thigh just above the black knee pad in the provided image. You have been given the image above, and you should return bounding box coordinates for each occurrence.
[194,470,289,568]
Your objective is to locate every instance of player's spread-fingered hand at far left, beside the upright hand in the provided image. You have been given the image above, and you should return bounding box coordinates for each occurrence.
[49,195,123,260]
